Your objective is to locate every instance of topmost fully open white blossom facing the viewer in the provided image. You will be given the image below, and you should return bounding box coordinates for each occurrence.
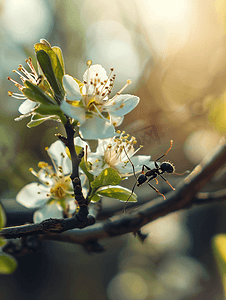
[60,61,140,139]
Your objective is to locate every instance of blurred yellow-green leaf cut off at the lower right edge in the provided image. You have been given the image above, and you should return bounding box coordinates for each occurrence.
[212,234,226,296]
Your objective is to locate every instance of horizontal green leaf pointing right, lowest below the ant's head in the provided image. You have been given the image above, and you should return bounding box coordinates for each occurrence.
[92,186,137,202]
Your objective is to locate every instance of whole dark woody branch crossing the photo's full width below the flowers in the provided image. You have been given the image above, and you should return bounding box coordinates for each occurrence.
[0,140,226,241]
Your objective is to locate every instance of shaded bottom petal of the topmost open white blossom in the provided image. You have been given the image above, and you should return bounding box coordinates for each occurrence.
[79,117,115,140]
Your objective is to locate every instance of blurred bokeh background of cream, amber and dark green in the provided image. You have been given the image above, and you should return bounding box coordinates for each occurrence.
[0,0,226,300]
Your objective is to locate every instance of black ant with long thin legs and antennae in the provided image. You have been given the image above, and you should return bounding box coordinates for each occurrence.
[124,140,177,213]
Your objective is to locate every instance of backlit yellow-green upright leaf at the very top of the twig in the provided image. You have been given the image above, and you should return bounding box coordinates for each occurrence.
[35,43,64,87]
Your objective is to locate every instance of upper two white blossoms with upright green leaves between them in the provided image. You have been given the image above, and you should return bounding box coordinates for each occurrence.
[8,40,140,139]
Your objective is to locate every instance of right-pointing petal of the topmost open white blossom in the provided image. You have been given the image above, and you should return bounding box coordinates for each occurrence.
[104,95,140,117]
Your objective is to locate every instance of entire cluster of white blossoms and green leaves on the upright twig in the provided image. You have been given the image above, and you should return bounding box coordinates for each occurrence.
[8,40,150,222]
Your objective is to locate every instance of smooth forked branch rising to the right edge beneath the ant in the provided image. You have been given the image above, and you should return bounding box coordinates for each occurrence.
[41,141,226,245]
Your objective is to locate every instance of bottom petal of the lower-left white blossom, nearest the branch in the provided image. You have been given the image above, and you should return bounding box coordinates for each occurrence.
[33,202,63,223]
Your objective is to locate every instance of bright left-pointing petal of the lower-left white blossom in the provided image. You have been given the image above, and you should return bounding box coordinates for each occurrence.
[16,182,50,208]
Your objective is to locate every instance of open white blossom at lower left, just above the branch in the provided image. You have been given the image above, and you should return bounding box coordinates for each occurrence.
[16,141,87,223]
